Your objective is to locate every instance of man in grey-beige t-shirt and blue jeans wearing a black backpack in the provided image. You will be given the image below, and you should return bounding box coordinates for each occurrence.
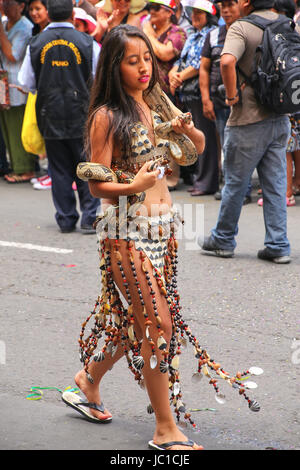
[198,0,298,264]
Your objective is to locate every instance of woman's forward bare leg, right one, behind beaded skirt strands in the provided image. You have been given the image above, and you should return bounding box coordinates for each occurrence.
[106,241,202,450]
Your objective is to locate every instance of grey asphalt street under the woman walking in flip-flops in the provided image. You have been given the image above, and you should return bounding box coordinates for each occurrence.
[0,179,300,451]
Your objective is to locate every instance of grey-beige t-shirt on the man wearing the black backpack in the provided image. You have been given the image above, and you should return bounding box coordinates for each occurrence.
[221,10,278,126]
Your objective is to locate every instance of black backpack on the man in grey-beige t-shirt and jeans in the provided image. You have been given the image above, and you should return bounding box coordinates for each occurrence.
[238,14,300,114]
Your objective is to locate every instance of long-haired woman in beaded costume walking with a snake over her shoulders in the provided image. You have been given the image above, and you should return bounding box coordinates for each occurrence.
[62,25,262,450]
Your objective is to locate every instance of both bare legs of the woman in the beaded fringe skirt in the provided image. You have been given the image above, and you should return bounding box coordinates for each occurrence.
[75,240,202,450]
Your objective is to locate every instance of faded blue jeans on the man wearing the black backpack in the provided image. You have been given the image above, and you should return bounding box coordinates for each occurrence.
[211,116,290,256]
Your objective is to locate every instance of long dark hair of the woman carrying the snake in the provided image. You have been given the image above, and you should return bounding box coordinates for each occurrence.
[86,24,159,162]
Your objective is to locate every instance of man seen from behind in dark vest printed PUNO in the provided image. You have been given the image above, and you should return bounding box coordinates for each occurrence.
[18,0,99,233]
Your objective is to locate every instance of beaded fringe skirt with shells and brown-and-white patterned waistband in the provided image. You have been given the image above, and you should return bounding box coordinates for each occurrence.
[79,208,263,427]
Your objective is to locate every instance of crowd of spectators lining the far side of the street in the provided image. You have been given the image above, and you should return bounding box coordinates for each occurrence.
[0,0,300,209]
